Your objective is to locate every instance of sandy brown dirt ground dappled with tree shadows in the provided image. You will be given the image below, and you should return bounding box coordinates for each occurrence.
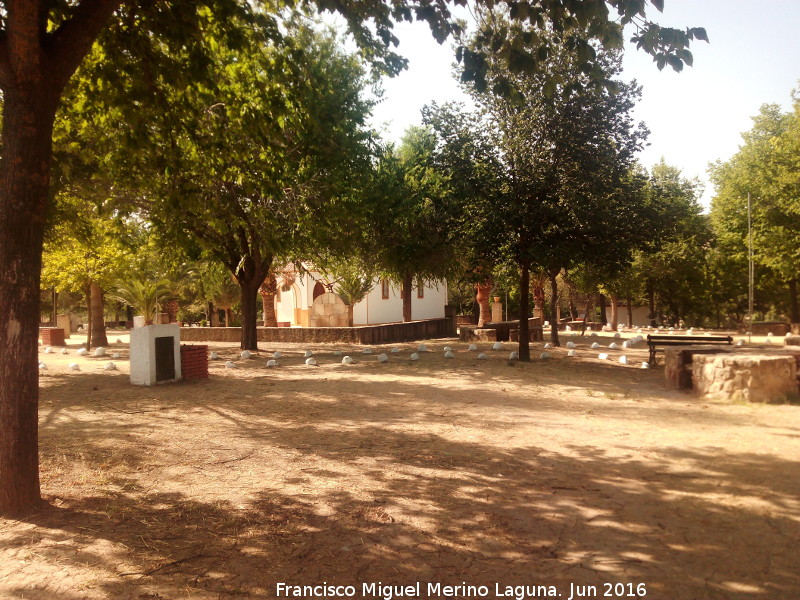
[0,332,800,600]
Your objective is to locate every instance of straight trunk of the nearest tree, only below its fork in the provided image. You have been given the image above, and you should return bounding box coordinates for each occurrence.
[0,92,55,514]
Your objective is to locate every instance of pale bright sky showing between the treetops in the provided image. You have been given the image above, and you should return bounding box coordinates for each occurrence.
[366,0,800,207]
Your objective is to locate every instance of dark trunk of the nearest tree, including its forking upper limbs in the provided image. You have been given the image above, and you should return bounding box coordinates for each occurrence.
[0,0,120,514]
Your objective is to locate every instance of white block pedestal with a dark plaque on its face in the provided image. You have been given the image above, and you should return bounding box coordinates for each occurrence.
[130,325,182,385]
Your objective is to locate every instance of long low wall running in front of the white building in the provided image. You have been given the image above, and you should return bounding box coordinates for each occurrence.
[181,319,456,345]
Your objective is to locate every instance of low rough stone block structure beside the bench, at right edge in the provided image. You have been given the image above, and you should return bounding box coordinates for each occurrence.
[692,353,798,402]
